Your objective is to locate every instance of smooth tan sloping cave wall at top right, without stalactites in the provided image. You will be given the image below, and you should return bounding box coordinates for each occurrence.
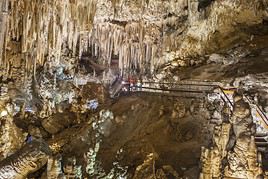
[171,0,267,60]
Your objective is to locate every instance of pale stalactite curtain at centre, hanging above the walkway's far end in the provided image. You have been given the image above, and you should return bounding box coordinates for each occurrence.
[80,22,161,75]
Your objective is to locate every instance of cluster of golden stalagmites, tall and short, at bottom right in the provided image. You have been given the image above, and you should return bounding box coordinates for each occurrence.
[200,97,262,179]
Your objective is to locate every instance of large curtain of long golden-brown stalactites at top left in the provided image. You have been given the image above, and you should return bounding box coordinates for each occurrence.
[8,0,97,73]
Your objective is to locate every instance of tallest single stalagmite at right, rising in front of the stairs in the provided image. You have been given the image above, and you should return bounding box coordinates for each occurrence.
[224,98,262,178]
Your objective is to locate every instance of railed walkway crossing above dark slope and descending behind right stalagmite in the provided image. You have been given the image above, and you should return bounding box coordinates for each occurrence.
[112,81,268,150]
